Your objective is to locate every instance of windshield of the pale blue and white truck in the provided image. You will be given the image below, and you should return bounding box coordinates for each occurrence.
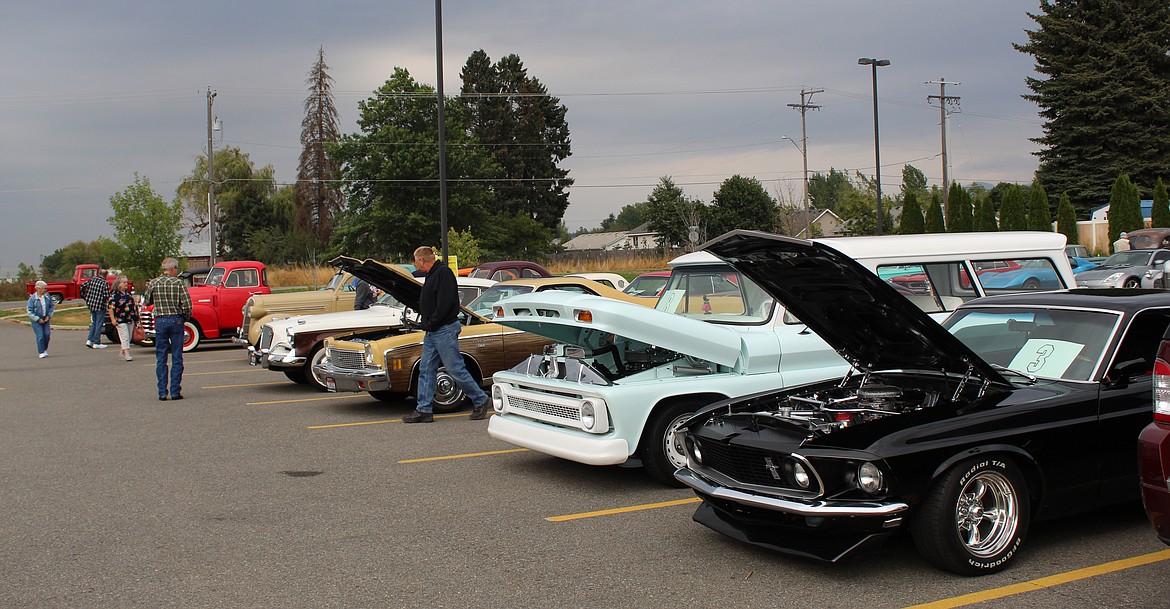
[655,267,776,324]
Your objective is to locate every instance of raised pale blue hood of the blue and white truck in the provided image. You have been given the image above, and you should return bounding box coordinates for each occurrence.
[493,290,742,367]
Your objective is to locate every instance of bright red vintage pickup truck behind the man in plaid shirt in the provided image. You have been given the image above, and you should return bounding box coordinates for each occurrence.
[139,261,271,352]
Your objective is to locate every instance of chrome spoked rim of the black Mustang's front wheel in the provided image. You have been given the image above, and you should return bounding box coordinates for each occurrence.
[955,471,1019,558]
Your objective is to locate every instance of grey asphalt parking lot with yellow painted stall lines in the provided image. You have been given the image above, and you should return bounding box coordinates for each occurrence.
[0,321,1170,609]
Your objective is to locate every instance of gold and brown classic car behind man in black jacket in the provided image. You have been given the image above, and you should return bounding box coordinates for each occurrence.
[314,268,650,413]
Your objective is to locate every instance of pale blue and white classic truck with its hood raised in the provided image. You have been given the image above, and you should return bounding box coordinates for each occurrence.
[488,231,1075,485]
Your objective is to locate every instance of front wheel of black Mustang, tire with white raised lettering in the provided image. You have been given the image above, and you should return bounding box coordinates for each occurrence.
[910,456,1031,575]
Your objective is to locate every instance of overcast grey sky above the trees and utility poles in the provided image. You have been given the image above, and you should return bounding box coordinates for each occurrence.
[0,0,1042,277]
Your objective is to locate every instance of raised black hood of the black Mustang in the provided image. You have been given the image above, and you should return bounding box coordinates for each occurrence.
[702,230,1007,385]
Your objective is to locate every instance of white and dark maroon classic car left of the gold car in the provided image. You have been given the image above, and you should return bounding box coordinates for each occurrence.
[248,273,495,390]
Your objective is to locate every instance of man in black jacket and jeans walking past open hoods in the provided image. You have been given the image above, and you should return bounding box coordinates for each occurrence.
[402,245,489,423]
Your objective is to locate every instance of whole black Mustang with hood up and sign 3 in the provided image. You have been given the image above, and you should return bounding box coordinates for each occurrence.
[675,231,1170,575]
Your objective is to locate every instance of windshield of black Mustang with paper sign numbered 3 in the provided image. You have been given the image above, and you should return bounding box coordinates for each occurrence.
[943,306,1120,381]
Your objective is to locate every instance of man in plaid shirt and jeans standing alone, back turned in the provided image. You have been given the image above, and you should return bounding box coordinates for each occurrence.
[143,258,191,401]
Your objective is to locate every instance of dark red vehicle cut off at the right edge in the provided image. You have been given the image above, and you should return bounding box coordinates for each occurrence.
[1137,330,1170,545]
